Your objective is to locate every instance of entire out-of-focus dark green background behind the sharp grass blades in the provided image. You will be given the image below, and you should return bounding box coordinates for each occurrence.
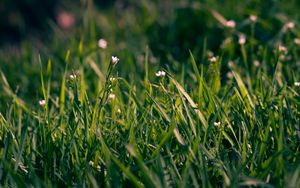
[0,0,300,104]
